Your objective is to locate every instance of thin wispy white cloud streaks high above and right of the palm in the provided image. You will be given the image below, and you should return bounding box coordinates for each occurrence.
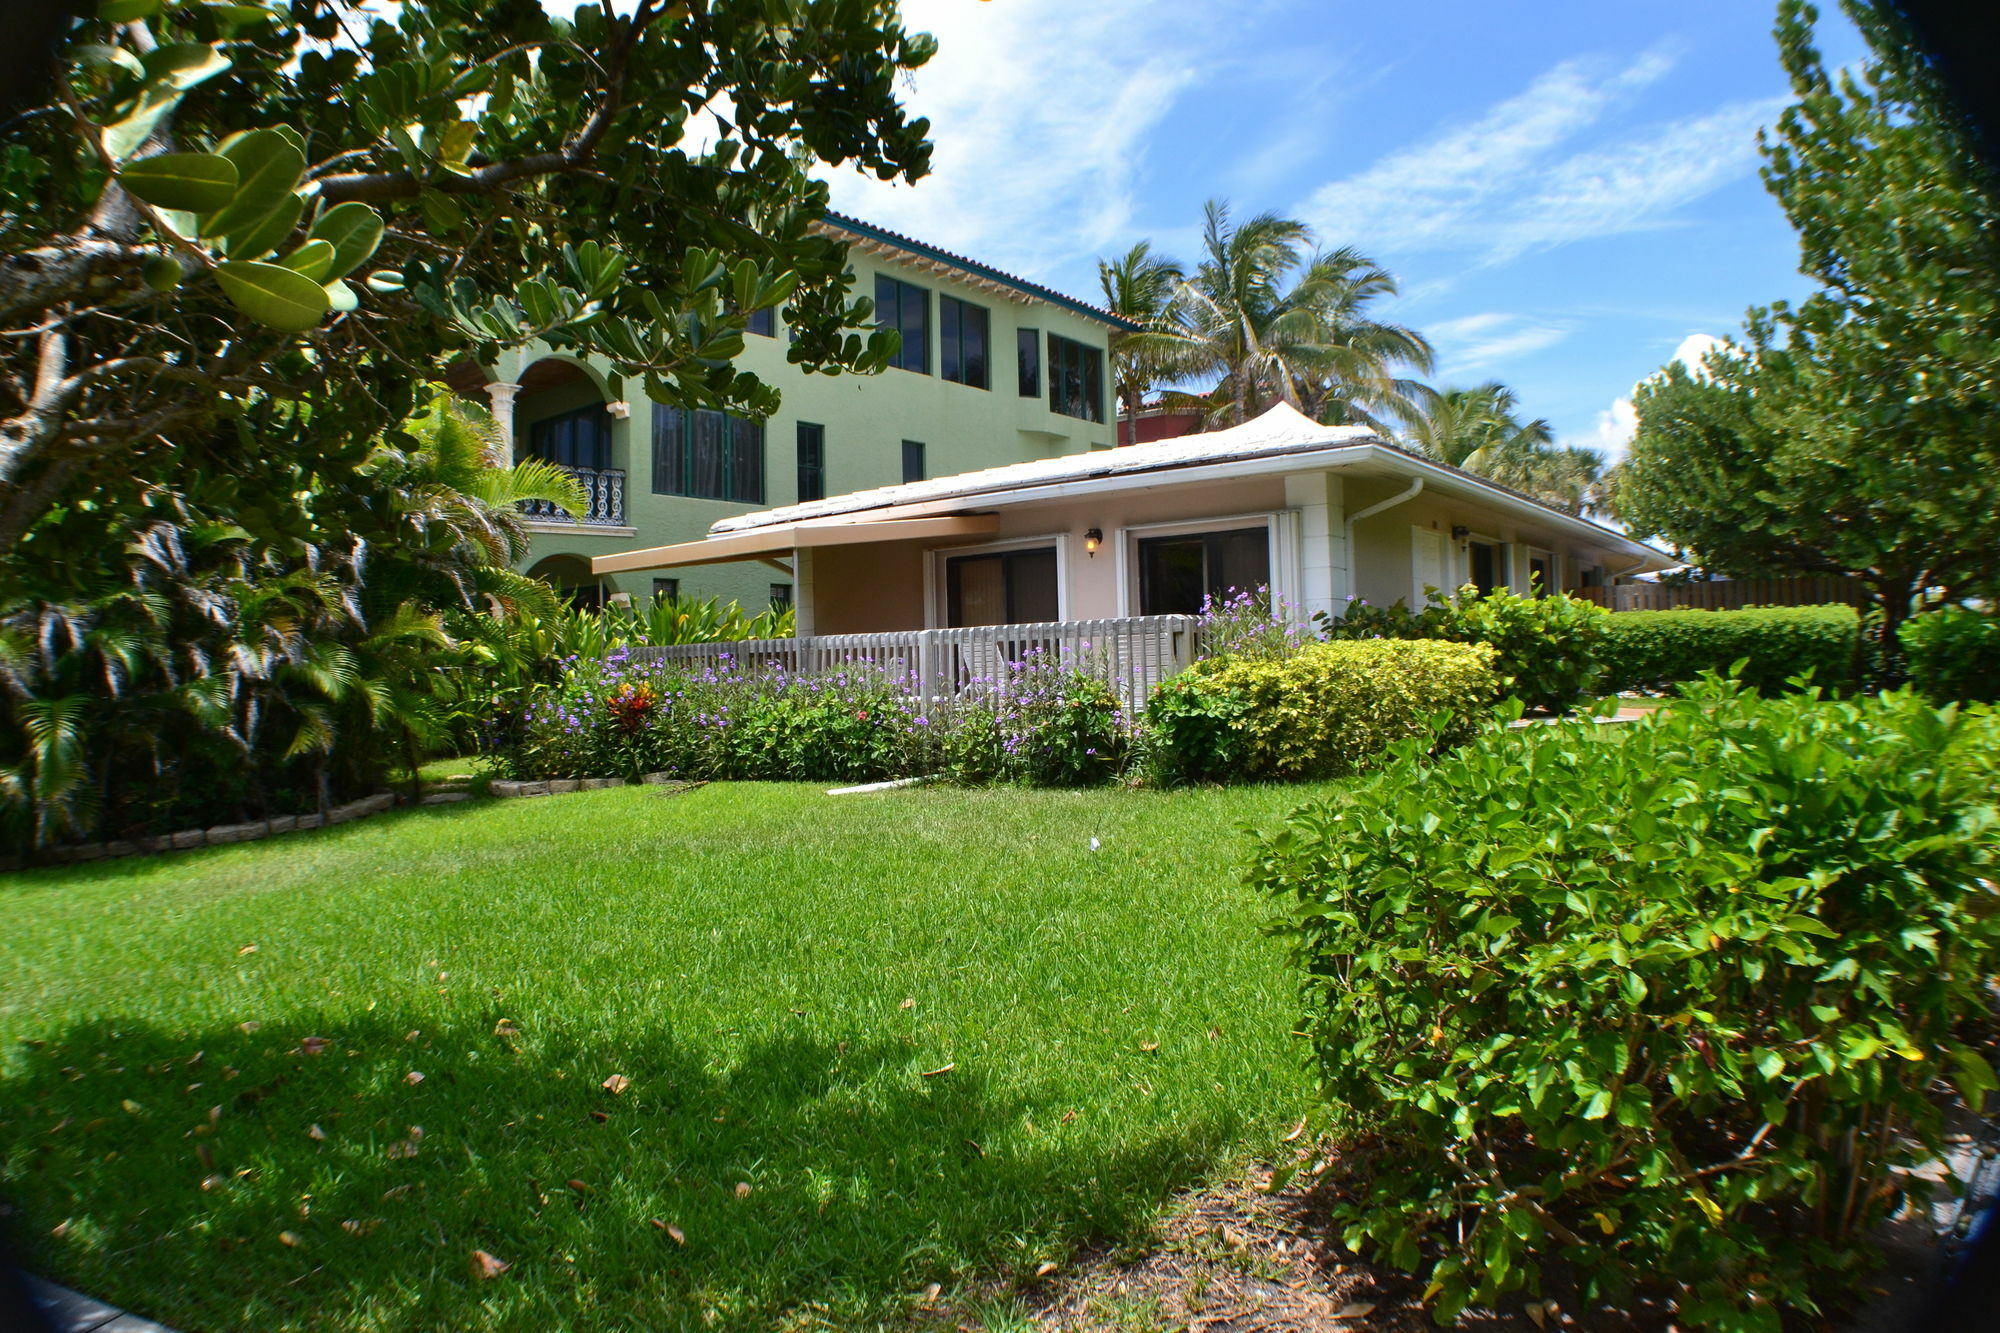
[1300,50,1780,264]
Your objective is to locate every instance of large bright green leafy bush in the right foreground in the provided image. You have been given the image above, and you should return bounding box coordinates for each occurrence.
[1250,677,2000,1333]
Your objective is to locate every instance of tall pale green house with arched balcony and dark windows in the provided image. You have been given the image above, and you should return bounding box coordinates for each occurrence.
[452,214,1126,608]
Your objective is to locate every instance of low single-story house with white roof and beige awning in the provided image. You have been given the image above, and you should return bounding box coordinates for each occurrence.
[592,404,1676,636]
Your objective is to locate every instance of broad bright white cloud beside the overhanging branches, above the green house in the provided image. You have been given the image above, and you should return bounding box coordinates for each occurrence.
[828,0,1200,274]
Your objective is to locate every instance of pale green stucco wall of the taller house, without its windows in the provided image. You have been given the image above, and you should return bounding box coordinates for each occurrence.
[494,250,1116,608]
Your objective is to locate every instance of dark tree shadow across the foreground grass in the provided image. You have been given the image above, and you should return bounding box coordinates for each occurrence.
[0,1011,1240,1333]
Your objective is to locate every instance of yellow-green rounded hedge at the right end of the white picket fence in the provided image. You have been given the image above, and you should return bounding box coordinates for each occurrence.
[1146,638,1500,783]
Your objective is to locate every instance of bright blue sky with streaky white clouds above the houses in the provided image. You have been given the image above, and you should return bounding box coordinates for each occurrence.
[830,0,1860,452]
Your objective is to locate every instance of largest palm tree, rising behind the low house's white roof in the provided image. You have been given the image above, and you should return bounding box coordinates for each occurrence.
[1128,200,1432,424]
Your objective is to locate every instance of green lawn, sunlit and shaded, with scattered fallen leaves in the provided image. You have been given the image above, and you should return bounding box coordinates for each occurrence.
[0,785,1336,1333]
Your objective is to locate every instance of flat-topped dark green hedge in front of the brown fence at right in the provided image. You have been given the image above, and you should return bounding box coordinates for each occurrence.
[1596,606,1860,695]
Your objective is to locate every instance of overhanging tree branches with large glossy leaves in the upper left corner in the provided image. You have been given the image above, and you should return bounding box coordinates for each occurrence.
[0,0,936,554]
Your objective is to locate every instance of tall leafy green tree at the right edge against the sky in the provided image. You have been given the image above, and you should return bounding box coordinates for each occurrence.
[1618,0,2000,681]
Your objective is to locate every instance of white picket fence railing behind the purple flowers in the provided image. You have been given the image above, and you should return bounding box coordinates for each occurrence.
[630,616,1194,705]
